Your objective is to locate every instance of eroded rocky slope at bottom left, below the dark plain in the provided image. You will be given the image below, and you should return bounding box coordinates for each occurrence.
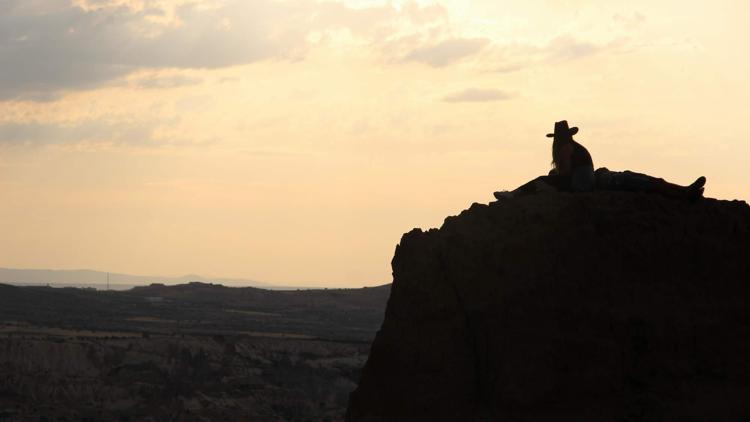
[0,331,367,422]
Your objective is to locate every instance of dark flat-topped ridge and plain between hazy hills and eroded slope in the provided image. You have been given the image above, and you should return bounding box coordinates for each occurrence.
[0,282,391,342]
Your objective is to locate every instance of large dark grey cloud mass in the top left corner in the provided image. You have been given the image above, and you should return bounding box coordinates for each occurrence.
[0,0,284,99]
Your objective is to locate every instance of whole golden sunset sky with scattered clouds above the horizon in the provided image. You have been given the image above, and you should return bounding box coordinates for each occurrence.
[0,0,750,287]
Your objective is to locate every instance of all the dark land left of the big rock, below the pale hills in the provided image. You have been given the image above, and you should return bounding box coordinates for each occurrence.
[0,283,390,421]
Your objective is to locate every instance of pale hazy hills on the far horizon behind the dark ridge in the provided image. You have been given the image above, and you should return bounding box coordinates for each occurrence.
[0,268,280,290]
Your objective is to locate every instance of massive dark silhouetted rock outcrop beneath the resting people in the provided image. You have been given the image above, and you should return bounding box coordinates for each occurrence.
[347,192,750,421]
